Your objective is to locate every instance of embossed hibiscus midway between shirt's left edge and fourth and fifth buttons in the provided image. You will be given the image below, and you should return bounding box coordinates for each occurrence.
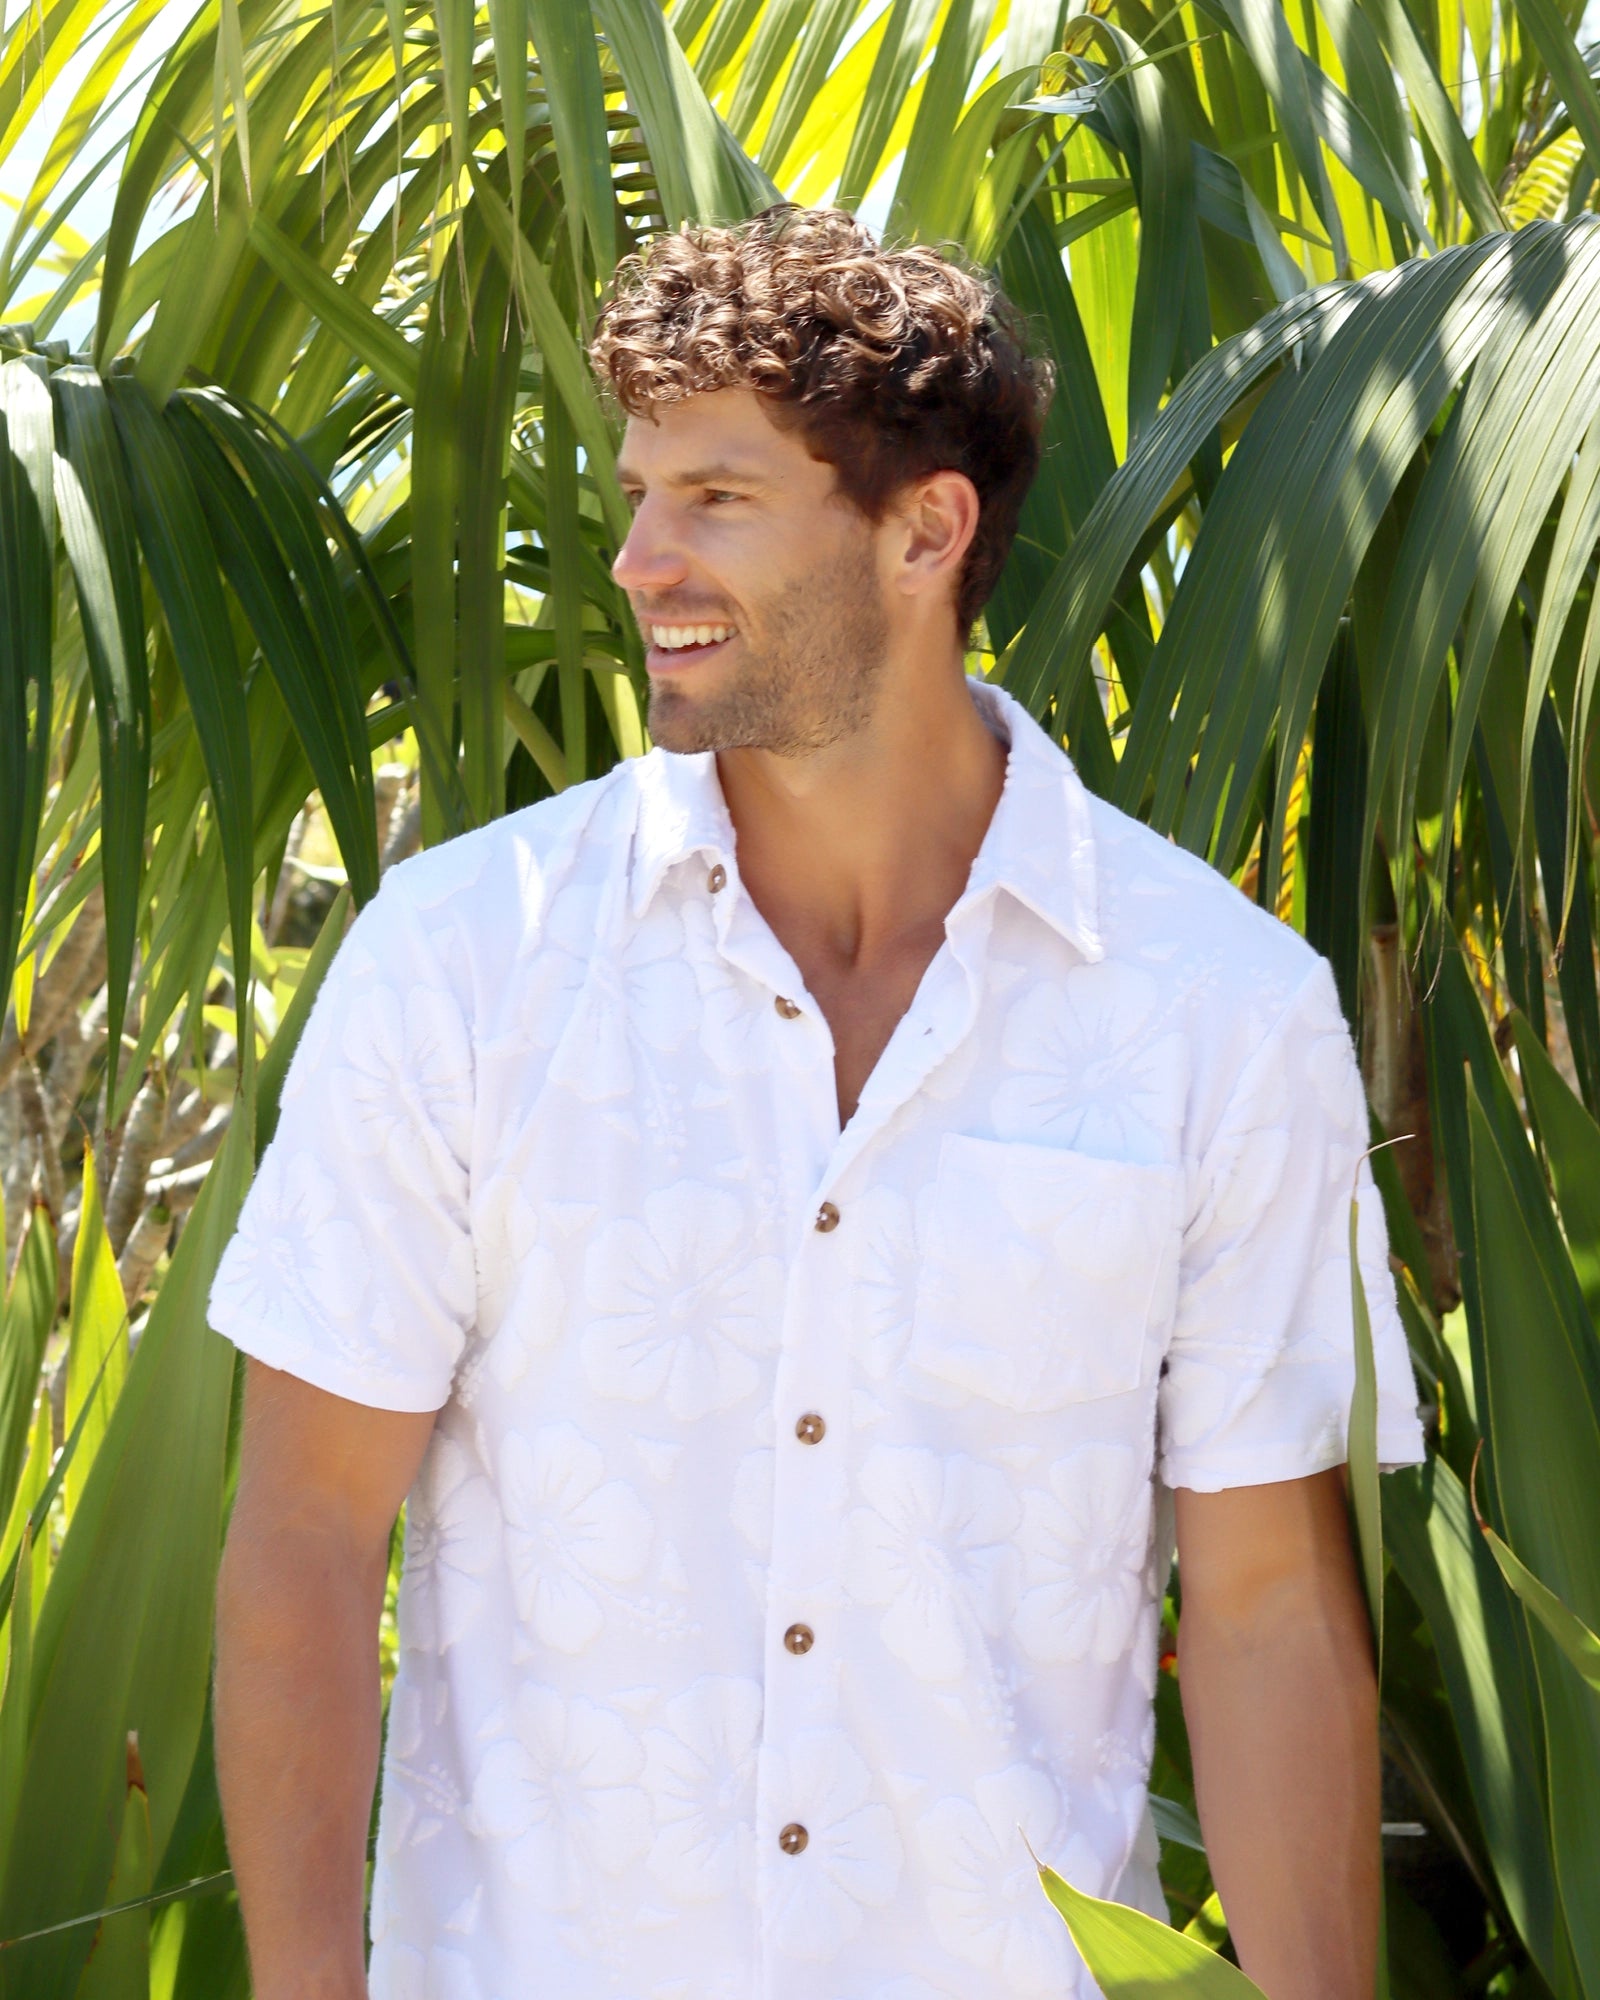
[500,1424,652,1654]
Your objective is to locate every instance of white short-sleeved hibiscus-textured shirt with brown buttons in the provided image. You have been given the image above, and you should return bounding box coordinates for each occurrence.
[212,684,1422,2000]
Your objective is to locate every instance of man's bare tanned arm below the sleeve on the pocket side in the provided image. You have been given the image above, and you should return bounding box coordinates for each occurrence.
[1176,1468,1382,2000]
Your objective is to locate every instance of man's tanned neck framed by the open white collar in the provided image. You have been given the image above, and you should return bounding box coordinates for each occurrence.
[718,660,1006,982]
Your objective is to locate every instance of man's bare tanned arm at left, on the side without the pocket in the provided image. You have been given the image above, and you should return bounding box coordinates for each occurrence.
[216,1360,434,2000]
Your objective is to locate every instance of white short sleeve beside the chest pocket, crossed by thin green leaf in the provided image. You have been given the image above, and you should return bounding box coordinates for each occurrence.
[1160,960,1424,1492]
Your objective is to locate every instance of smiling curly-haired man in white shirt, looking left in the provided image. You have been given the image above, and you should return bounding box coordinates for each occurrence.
[212,210,1422,2000]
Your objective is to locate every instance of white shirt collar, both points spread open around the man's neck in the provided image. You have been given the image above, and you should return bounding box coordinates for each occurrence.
[630,680,1104,960]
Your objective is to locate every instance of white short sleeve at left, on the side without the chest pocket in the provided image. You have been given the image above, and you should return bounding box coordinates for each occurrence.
[210,870,476,1410]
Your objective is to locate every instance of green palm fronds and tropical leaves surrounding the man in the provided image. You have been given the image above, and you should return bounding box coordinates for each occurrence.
[0,0,1600,2000]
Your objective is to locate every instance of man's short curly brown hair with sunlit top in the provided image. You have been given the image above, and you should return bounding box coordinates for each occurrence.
[590,202,1054,632]
